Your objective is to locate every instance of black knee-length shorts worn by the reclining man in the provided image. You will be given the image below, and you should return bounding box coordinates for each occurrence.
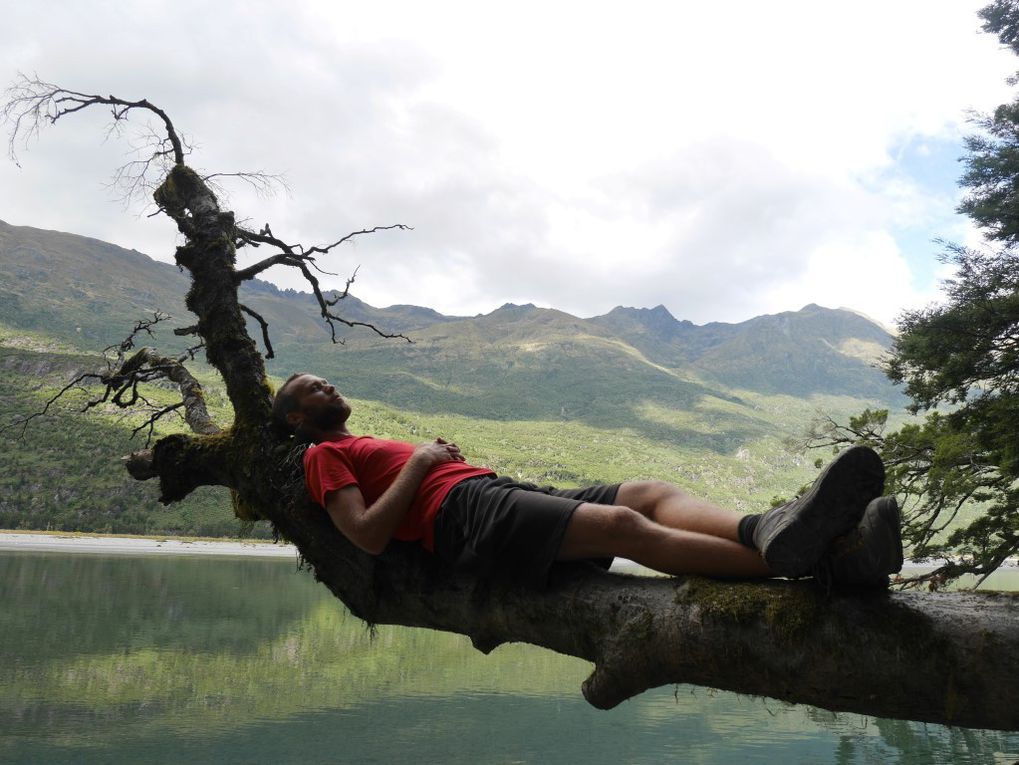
[435,476,620,587]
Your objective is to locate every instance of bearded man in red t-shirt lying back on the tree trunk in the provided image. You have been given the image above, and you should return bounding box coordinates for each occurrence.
[273,374,903,587]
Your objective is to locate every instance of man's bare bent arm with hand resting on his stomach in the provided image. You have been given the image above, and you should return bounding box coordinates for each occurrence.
[325,438,465,555]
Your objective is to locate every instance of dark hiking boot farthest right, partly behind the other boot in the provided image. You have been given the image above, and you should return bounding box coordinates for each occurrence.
[814,497,903,587]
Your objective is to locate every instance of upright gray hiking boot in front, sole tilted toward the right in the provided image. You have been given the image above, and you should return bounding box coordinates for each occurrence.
[753,446,884,577]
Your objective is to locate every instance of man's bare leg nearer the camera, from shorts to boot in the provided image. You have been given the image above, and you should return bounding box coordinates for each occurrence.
[557,499,774,578]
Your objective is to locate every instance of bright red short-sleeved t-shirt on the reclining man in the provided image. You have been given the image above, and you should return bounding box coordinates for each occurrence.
[305,436,495,550]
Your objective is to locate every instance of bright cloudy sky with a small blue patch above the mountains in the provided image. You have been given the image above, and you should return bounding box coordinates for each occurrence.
[0,0,1019,323]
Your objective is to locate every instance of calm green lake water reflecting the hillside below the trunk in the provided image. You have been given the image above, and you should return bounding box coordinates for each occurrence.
[0,552,1019,765]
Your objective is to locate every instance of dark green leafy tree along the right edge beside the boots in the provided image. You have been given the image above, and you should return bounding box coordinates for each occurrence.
[810,0,1019,586]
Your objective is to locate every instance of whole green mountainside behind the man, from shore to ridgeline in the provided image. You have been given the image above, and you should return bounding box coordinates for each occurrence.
[0,217,901,536]
